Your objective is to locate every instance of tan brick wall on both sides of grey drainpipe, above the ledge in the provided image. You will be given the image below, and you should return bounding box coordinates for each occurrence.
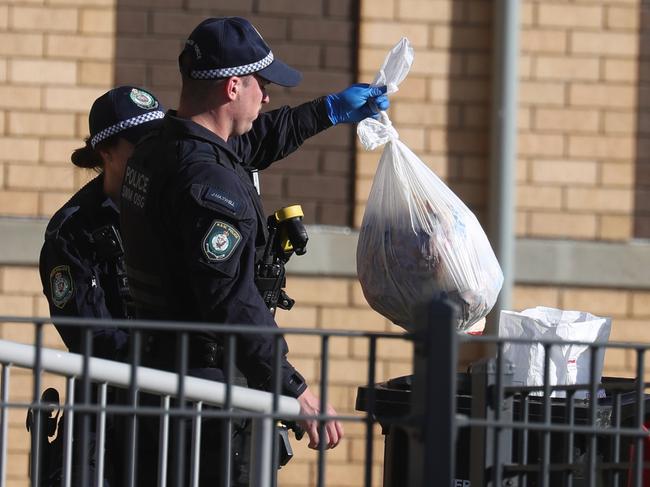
[355,0,650,241]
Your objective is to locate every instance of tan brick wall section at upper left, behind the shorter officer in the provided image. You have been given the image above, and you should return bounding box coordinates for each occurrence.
[0,0,114,216]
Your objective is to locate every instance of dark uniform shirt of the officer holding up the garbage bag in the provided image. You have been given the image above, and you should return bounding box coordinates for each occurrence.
[121,99,331,396]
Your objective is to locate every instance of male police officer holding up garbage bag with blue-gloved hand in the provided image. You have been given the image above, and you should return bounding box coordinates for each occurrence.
[122,17,388,483]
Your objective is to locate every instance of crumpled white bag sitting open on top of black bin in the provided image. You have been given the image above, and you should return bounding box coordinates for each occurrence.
[499,306,612,399]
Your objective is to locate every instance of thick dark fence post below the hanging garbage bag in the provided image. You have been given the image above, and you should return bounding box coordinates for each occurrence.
[404,299,458,487]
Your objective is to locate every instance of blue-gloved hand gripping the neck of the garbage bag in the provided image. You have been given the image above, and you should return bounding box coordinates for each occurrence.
[325,83,390,125]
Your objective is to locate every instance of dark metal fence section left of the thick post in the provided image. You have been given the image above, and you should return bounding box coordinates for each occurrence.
[0,317,410,487]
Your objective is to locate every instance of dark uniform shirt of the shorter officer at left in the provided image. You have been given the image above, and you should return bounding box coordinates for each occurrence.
[39,175,128,358]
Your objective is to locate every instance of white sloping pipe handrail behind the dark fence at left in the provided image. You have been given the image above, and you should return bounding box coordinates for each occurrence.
[0,340,300,415]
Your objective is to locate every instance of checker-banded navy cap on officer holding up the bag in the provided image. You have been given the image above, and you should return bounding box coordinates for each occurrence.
[179,17,302,86]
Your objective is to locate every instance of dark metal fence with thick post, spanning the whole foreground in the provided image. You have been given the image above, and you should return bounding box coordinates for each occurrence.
[0,301,650,487]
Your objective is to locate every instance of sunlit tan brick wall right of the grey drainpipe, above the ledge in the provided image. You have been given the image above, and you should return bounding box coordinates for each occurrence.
[517,0,641,240]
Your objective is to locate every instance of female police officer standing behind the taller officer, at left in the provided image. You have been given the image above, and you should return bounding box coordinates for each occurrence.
[39,86,164,486]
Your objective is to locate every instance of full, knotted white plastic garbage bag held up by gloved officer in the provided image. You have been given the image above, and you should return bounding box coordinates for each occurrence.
[357,38,503,330]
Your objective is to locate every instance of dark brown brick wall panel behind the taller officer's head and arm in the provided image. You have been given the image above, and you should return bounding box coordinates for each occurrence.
[115,0,357,225]
